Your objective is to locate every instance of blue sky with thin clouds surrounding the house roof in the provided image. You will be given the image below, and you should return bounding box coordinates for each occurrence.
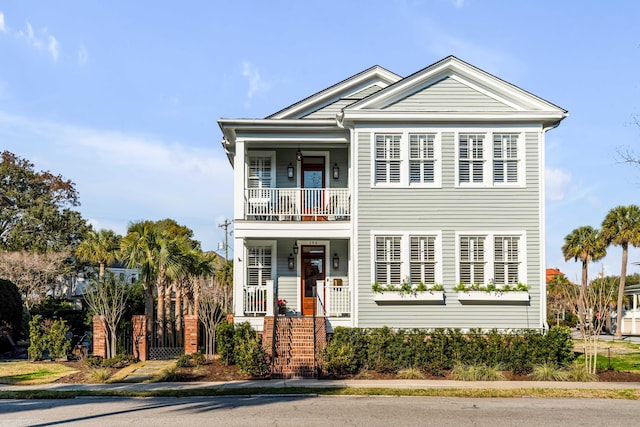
[0,0,640,281]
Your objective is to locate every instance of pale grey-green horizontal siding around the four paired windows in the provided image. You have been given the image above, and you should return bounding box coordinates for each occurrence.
[356,126,543,329]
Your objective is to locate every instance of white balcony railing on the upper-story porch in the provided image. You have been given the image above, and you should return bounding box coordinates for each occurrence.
[245,188,351,221]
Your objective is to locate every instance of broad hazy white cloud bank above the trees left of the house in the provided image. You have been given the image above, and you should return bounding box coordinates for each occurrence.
[0,111,233,254]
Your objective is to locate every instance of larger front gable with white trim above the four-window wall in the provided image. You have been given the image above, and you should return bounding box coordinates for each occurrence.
[342,56,567,125]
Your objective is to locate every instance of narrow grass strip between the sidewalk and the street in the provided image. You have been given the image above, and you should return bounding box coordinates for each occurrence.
[0,387,640,400]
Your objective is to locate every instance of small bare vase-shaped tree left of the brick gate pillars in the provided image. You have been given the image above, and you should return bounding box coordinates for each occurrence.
[84,275,128,358]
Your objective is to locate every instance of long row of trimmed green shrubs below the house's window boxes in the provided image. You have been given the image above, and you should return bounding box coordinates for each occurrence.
[324,326,575,376]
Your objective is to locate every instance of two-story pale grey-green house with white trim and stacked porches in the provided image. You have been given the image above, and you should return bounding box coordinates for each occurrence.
[218,56,567,331]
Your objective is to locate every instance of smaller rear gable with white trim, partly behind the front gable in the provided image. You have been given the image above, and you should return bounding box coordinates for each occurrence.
[266,65,402,119]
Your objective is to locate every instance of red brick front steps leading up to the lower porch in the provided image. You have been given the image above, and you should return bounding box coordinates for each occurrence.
[262,316,327,378]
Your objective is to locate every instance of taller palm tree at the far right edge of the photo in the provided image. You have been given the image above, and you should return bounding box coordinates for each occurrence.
[602,205,640,338]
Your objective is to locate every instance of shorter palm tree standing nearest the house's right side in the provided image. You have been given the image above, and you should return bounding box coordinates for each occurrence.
[562,225,607,324]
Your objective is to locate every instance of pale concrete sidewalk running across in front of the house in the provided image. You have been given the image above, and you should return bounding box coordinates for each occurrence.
[0,379,640,391]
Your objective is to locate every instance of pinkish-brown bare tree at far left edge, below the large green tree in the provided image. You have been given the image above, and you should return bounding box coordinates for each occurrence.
[0,251,69,309]
